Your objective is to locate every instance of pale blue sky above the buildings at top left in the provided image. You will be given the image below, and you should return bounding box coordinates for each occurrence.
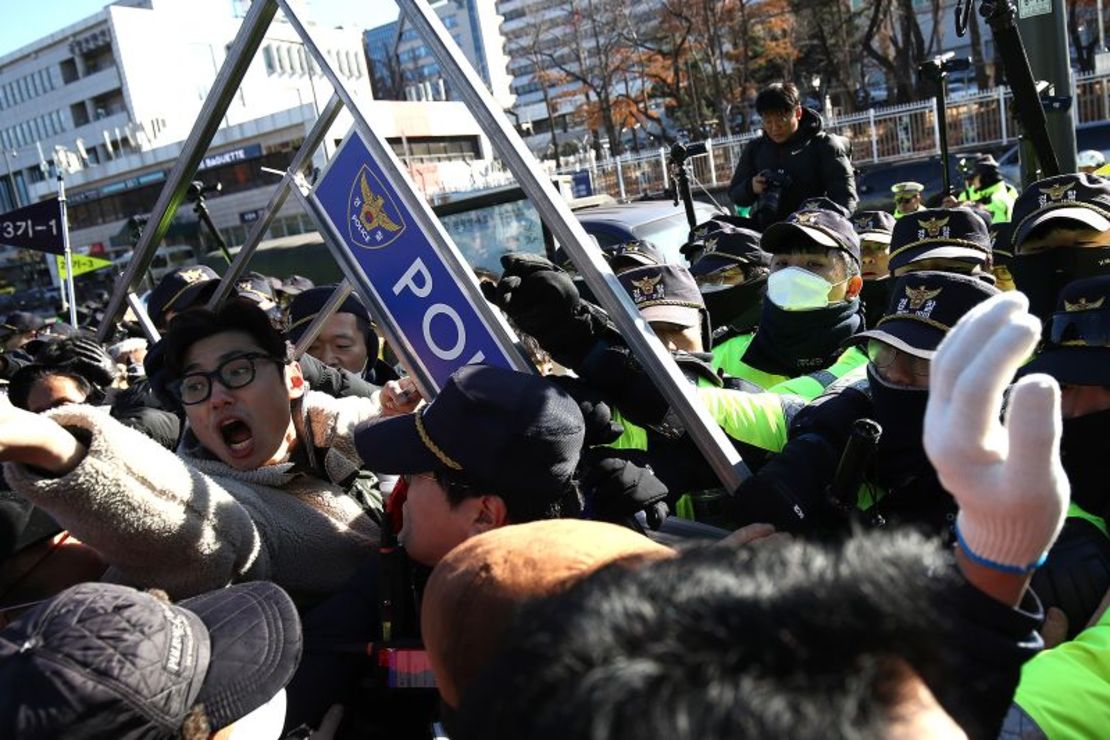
[0,0,397,55]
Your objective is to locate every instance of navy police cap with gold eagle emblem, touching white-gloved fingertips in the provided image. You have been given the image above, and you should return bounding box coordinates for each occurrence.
[850,271,999,358]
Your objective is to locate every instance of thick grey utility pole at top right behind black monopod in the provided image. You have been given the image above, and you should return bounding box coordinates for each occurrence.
[1015,0,1076,185]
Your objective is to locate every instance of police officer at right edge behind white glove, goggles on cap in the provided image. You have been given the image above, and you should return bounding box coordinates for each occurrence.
[1003,275,1110,738]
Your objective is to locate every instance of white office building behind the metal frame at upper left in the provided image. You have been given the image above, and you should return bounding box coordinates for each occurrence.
[0,0,499,286]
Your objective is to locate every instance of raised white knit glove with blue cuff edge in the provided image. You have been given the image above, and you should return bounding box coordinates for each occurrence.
[925,292,1070,572]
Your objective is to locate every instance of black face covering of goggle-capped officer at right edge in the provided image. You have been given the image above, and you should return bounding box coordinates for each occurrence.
[1060,410,1110,517]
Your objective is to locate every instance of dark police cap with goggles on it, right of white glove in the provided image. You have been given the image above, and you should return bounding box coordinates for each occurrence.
[1020,275,1110,386]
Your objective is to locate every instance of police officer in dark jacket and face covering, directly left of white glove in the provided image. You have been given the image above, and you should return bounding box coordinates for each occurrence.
[734,272,998,533]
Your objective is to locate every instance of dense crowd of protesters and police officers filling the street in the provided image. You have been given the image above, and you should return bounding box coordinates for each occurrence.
[0,78,1110,740]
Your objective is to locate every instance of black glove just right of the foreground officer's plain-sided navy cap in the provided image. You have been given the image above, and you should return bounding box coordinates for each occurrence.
[579,447,669,529]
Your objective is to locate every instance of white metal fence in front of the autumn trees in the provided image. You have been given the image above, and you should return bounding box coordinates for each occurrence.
[561,73,1110,201]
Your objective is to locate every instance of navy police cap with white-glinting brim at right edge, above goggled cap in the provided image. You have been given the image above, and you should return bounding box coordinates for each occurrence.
[1011,172,1110,255]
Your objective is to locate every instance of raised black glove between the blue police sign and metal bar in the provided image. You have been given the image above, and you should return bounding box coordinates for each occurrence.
[486,254,616,367]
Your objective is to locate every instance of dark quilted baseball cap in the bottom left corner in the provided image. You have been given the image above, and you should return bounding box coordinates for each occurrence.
[0,581,302,739]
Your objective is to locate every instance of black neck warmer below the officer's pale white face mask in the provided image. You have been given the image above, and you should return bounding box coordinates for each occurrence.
[744,300,864,377]
